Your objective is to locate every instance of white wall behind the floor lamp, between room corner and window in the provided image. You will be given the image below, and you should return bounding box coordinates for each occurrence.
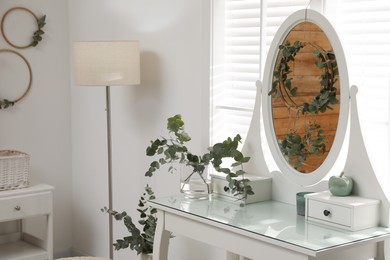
[69,0,223,260]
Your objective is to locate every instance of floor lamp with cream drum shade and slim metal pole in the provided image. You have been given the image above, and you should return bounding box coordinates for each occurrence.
[73,41,140,259]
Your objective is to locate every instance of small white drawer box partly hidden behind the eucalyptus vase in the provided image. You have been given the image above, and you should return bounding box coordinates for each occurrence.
[210,173,272,204]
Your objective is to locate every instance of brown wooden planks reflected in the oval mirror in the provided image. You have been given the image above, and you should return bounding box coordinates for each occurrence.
[272,22,340,173]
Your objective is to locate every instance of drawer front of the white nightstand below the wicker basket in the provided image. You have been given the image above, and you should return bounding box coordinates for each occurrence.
[0,192,52,221]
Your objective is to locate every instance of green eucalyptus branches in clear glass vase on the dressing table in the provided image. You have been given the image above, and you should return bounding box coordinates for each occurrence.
[145,115,254,203]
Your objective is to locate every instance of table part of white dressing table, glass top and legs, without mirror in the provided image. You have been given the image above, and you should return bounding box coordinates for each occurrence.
[150,196,390,260]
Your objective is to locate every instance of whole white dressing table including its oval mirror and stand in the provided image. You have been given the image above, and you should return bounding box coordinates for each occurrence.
[150,9,390,260]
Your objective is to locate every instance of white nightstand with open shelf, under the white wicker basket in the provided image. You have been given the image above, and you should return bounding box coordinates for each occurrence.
[0,184,54,260]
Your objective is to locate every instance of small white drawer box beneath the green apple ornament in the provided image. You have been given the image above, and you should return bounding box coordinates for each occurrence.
[305,191,380,231]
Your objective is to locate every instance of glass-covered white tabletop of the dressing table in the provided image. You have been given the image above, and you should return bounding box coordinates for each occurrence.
[150,195,390,252]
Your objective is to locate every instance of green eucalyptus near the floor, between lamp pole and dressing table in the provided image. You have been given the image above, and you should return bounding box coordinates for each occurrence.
[102,185,157,259]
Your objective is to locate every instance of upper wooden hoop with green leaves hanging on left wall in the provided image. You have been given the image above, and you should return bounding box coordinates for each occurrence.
[1,7,46,49]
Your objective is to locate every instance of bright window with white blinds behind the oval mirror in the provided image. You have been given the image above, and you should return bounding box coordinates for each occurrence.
[210,0,390,190]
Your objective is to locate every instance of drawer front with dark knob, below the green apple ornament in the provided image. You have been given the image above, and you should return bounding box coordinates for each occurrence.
[308,200,352,227]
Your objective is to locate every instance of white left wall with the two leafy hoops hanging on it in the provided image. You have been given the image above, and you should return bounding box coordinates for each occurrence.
[0,0,72,255]
